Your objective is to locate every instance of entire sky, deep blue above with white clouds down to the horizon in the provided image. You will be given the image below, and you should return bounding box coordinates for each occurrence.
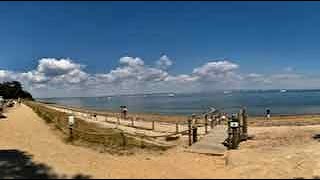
[0,1,320,97]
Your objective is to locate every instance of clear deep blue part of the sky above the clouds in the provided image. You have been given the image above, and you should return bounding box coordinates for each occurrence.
[0,2,320,96]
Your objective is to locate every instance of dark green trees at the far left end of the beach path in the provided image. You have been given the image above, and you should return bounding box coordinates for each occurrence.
[0,81,33,100]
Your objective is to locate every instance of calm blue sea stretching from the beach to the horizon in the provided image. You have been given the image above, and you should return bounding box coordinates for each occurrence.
[40,90,320,116]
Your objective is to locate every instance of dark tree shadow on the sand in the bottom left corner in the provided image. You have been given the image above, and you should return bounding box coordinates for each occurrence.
[0,150,90,179]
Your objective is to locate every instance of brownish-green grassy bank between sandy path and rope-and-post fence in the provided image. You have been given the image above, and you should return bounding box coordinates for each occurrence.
[24,101,167,154]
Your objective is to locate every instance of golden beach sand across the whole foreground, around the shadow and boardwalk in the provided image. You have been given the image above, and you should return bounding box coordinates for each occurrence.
[0,105,320,178]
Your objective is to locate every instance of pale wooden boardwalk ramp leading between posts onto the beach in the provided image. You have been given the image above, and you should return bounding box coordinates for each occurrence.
[186,125,228,156]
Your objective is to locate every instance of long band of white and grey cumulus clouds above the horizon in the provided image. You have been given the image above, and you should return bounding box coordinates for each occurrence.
[0,55,320,97]
